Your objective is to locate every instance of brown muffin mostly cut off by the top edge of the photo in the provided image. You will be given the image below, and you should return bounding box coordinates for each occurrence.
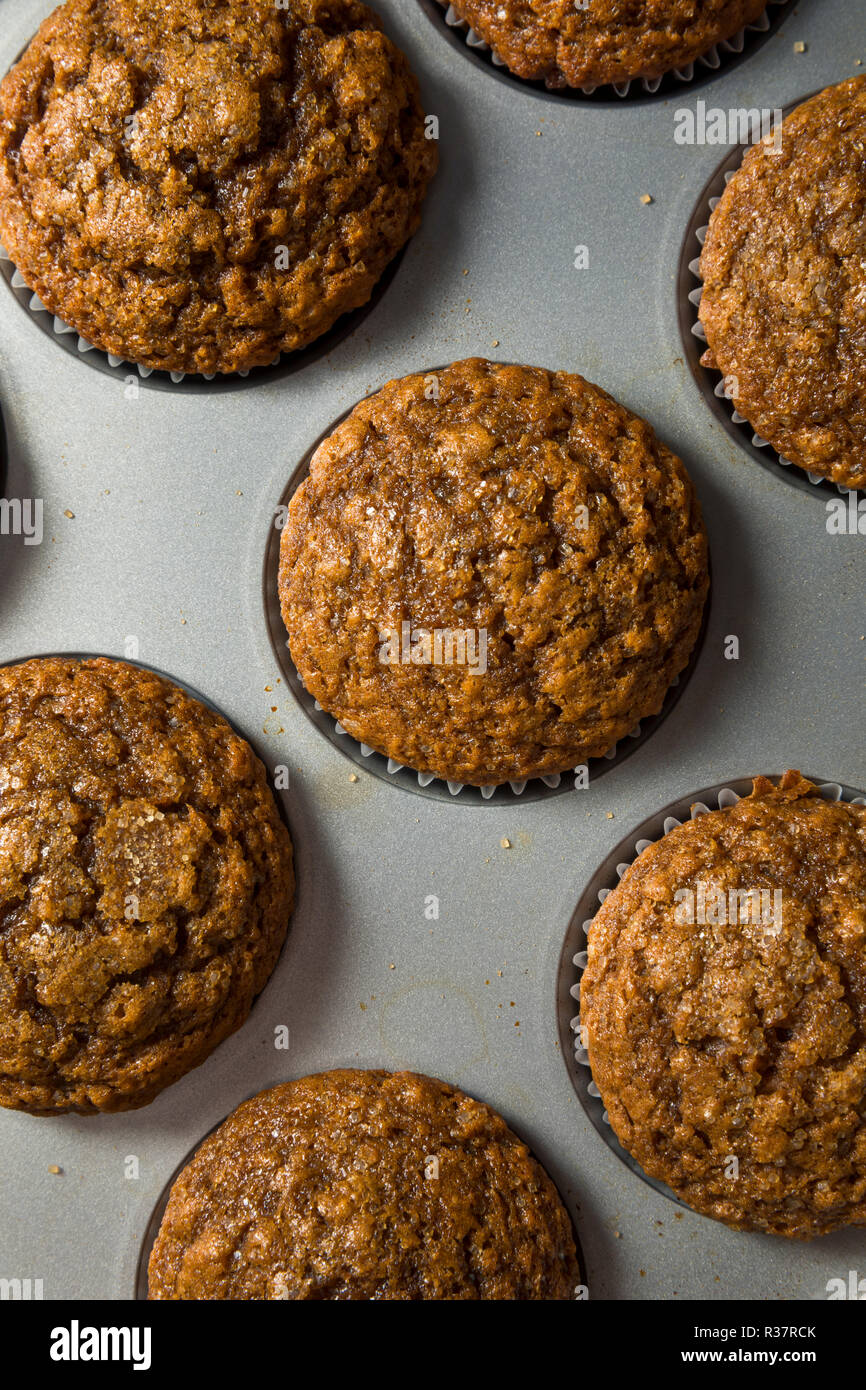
[452,0,767,88]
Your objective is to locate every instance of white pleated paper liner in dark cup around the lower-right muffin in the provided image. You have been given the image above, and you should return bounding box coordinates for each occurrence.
[556,774,866,1211]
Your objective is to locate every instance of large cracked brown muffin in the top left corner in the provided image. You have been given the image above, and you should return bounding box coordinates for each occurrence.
[0,0,436,374]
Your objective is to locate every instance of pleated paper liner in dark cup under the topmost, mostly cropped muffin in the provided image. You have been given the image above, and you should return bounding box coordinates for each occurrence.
[421,0,794,104]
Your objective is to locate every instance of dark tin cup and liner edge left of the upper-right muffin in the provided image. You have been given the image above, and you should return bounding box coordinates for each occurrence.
[677,107,855,499]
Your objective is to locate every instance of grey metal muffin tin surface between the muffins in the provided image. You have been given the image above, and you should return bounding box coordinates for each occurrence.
[0,0,866,1301]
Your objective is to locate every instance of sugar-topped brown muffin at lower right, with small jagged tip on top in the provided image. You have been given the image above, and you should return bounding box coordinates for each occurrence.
[581,771,866,1238]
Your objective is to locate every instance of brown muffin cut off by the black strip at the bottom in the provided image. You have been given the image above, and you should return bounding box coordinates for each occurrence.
[149,1070,580,1300]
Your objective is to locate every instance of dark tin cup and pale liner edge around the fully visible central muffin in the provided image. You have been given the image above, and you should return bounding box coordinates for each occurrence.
[261,366,712,806]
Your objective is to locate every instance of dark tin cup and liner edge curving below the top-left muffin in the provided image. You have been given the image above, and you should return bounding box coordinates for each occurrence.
[0,243,406,393]
